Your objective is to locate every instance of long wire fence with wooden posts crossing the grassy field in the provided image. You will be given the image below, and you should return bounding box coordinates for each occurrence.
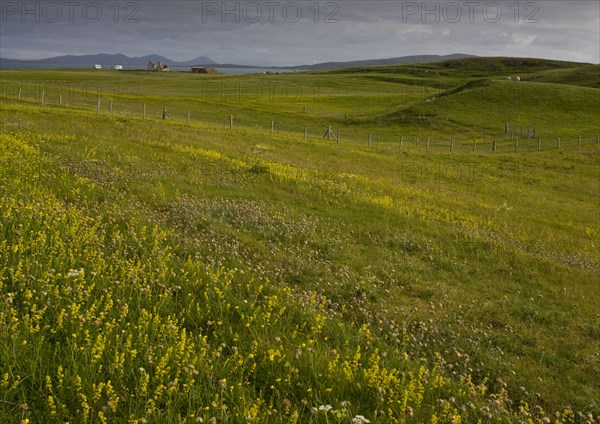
[2,91,600,153]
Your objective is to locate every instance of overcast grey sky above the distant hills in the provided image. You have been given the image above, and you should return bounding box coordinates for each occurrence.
[0,0,600,66]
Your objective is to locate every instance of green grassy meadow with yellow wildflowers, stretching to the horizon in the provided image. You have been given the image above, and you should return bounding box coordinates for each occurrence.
[0,59,600,423]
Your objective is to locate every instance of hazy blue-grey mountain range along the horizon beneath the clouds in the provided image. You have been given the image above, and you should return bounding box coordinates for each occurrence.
[0,53,475,70]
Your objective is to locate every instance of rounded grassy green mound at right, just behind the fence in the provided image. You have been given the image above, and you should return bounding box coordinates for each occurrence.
[394,79,600,140]
